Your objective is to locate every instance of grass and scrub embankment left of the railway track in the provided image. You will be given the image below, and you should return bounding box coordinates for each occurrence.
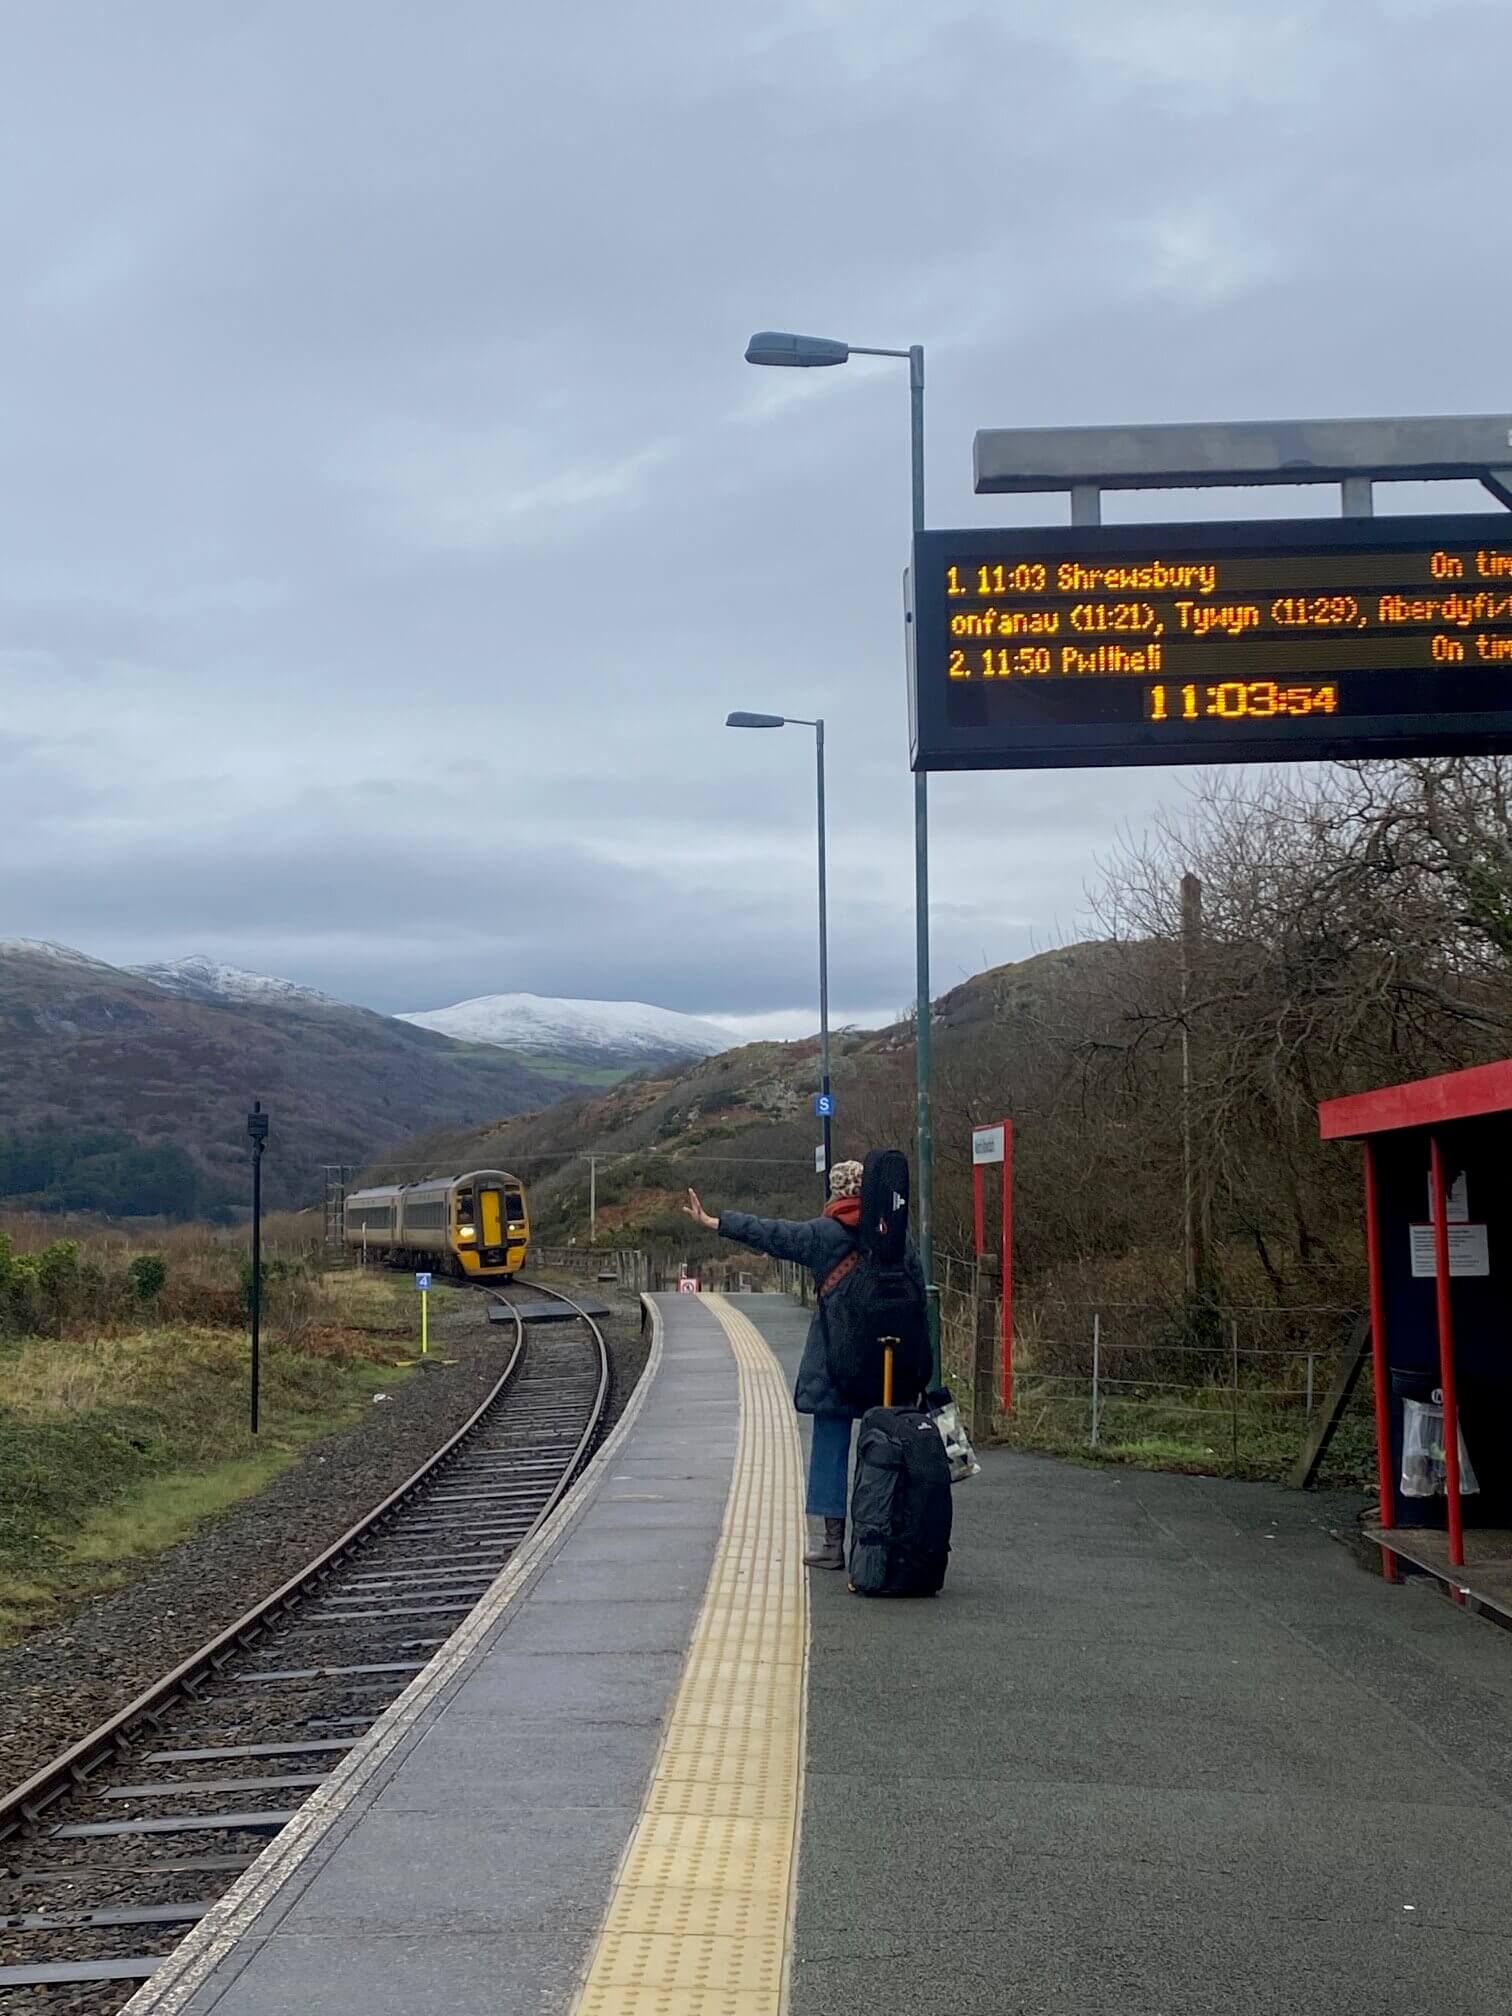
[0,1242,448,1643]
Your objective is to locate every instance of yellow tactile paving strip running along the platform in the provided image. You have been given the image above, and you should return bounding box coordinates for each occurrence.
[577,1296,808,2016]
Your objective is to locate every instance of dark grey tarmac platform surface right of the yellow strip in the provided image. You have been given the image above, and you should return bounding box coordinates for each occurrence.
[753,1296,1512,2016]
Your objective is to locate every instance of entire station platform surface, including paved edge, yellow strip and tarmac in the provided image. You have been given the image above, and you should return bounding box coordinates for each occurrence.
[131,1296,1512,2016]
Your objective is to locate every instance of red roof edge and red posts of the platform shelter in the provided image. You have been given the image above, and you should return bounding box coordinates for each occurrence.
[1318,1062,1512,1568]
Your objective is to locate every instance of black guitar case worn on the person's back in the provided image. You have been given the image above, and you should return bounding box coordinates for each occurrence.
[818,1147,933,1409]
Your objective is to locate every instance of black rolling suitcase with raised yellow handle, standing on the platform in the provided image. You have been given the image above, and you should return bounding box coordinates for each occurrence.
[849,1345,952,1597]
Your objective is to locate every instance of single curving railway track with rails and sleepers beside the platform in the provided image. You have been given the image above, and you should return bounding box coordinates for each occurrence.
[0,1280,609,2016]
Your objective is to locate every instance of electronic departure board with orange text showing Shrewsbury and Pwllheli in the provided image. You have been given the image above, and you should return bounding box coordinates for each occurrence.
[909,514,1512,770]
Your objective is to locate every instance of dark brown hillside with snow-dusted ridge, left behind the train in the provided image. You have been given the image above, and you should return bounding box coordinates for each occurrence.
[0,941,571,1216]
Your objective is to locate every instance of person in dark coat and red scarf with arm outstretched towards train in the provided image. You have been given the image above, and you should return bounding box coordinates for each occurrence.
[683,1161,923,1568]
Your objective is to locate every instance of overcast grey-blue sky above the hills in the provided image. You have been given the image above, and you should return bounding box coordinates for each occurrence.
[0,0,1512,1030]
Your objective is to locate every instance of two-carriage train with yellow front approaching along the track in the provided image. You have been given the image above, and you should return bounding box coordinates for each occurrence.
[343,1169,530,1280]
